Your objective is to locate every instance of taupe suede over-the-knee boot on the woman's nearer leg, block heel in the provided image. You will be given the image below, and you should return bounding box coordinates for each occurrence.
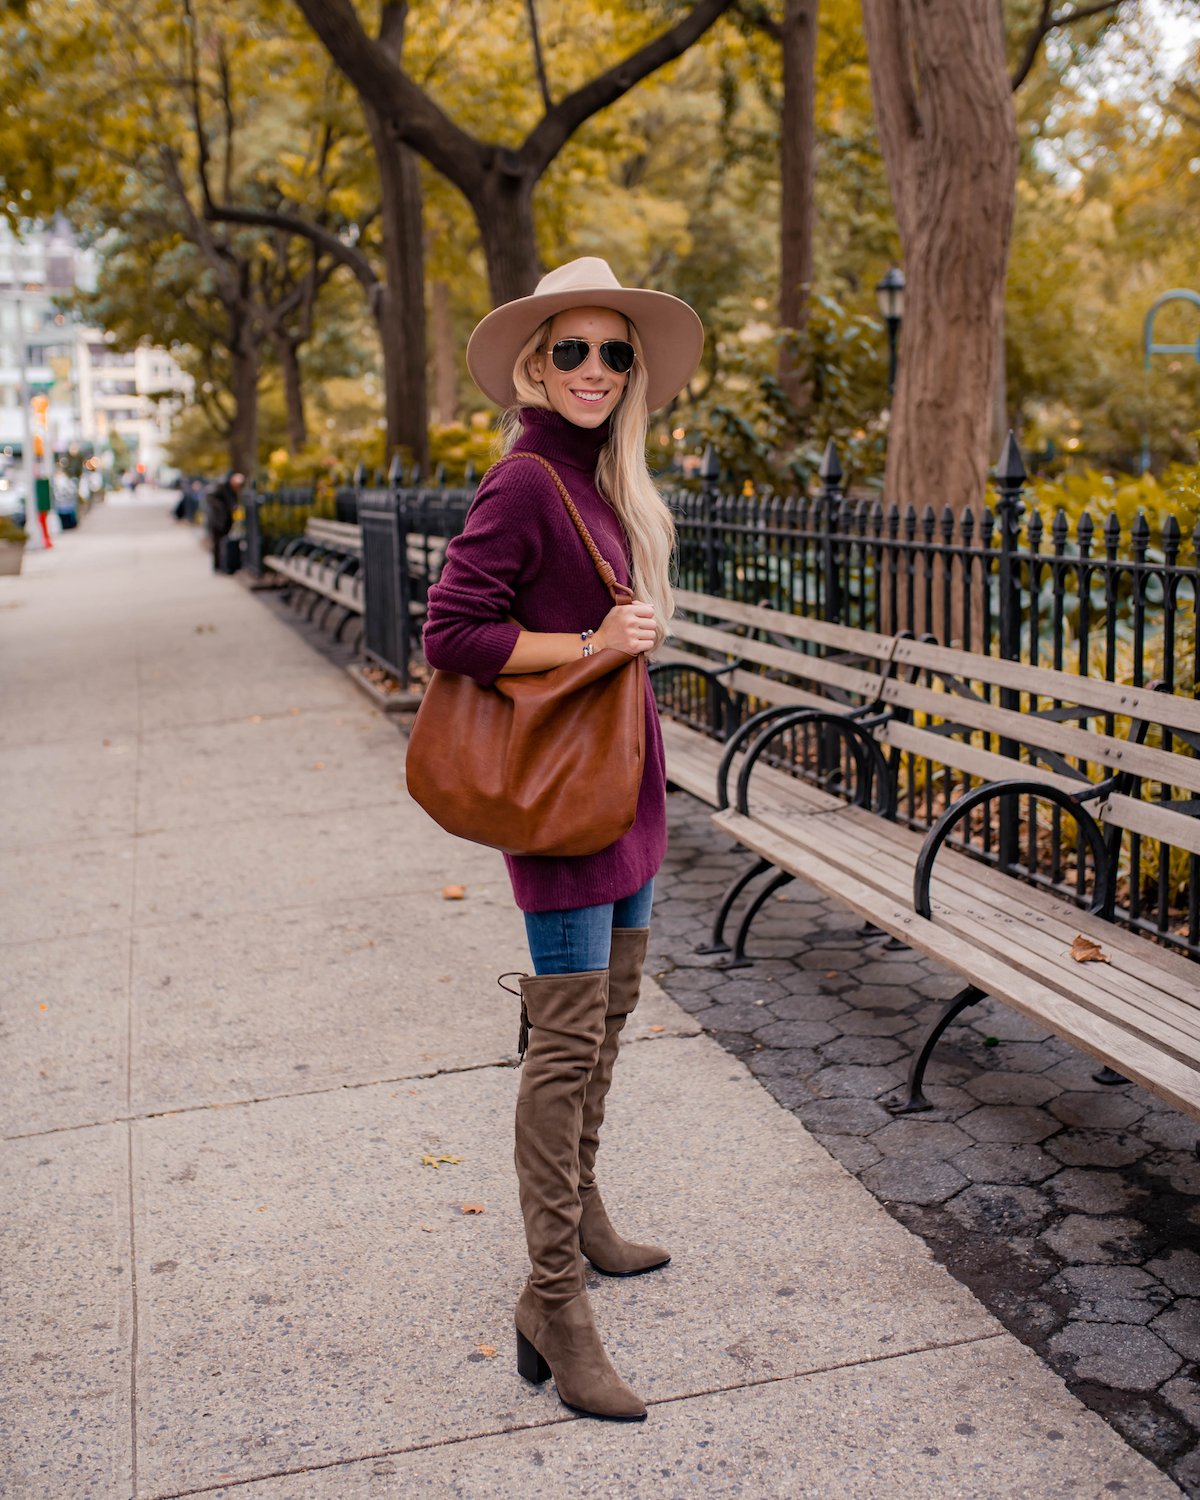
[515,969,647,1422]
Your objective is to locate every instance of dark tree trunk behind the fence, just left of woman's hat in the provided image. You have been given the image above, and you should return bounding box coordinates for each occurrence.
[366,108,429,476]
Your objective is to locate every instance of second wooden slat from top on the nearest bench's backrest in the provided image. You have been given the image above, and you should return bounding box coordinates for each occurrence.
[882,678,1200,792]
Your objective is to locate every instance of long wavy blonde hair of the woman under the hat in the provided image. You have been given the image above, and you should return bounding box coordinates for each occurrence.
[501,318,675,647]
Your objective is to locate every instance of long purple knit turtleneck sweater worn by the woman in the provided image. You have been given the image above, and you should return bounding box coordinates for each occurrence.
[425,407,666,912]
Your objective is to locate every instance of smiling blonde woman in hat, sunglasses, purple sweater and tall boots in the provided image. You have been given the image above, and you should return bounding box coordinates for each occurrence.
[425,257,704,1422]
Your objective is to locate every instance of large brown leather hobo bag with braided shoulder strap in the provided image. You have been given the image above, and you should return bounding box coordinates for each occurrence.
[407,453,647,855]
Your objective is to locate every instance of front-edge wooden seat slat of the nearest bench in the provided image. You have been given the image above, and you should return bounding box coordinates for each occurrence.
[713,809,1200,1119]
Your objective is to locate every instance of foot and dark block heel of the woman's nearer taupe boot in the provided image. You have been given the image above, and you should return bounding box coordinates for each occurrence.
[516,1287,647,1422]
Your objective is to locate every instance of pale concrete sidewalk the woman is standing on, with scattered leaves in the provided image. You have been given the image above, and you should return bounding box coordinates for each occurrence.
[0,507,1179,1500]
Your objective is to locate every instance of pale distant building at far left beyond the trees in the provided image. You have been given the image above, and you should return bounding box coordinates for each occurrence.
[0,215,192,477]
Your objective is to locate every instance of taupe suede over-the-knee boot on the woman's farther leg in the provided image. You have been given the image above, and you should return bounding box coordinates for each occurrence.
[579,927,671,1277]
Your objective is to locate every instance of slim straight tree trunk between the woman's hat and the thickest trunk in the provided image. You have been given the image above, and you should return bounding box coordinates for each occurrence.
[779,0,819,411]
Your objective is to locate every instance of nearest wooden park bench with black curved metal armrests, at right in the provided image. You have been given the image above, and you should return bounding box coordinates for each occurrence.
[675,600,1200,1118]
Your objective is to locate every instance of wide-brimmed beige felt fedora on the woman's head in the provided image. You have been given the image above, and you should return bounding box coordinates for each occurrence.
[467,255,704,411]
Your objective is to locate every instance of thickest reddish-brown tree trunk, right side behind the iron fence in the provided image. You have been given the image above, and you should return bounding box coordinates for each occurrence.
[863,0,1017,516]
